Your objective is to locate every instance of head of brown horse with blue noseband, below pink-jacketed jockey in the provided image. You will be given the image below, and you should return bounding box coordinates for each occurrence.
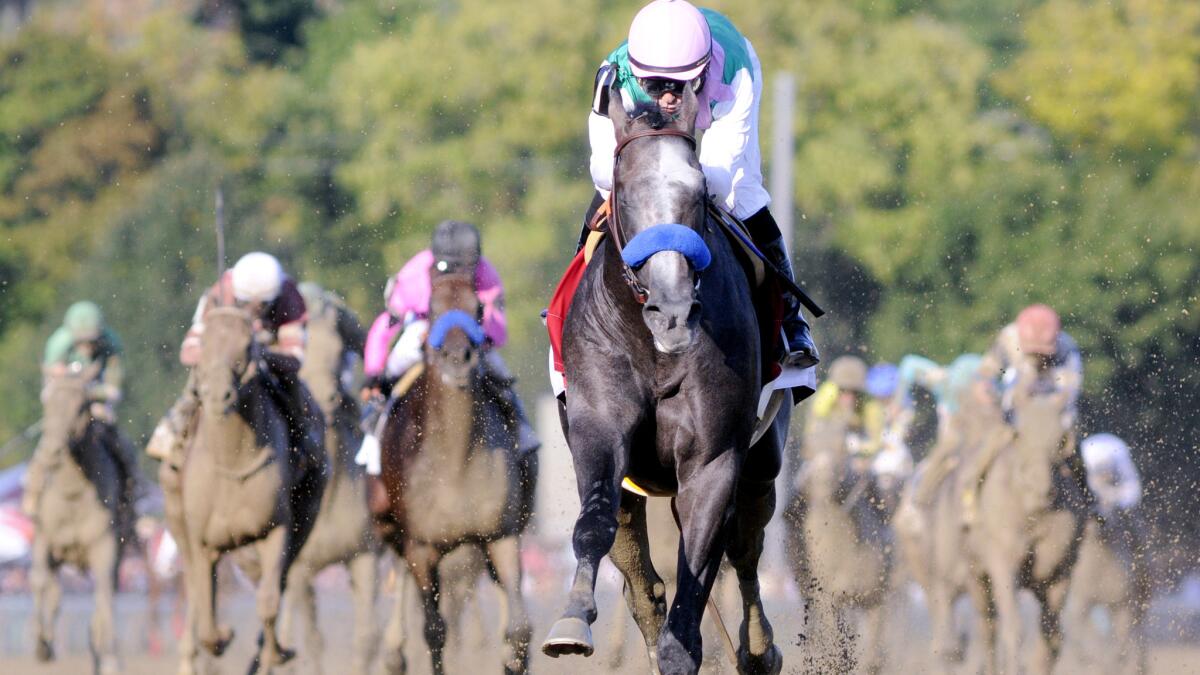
[425,274,485,389]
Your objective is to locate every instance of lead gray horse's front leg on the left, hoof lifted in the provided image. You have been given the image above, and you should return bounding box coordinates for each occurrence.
[541,422,628,657]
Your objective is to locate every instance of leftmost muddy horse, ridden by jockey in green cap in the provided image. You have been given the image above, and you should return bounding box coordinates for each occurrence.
[30,369,121,675]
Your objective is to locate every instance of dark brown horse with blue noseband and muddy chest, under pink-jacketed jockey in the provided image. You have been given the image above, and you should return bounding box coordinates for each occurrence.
[378,270,538,675]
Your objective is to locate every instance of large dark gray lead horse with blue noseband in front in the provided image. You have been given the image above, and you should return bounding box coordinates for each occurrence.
[542,79,791,674]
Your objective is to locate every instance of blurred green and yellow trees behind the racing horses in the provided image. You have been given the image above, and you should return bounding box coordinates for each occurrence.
[0,0,1200,559]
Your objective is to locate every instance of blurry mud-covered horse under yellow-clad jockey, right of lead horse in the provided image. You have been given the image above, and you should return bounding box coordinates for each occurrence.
[785,413,898,673]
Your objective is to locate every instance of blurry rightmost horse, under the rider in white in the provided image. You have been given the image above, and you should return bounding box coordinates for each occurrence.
[1063,509,1151,673]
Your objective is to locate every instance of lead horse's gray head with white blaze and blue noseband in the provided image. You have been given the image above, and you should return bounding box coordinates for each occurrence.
[608,79,712,354]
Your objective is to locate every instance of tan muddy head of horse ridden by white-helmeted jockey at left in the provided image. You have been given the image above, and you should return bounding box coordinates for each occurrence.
[196,307,254,416]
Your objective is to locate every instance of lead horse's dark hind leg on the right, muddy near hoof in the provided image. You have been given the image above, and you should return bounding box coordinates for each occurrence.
[726,479,784,675]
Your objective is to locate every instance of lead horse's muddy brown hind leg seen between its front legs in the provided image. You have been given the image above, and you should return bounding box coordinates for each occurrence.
[608,490,667,670]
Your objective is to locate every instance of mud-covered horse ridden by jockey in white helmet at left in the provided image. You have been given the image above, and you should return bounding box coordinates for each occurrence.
[171,307,326,671]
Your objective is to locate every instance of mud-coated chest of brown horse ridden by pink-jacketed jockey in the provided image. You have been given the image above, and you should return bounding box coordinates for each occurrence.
[404,448,511,542]
